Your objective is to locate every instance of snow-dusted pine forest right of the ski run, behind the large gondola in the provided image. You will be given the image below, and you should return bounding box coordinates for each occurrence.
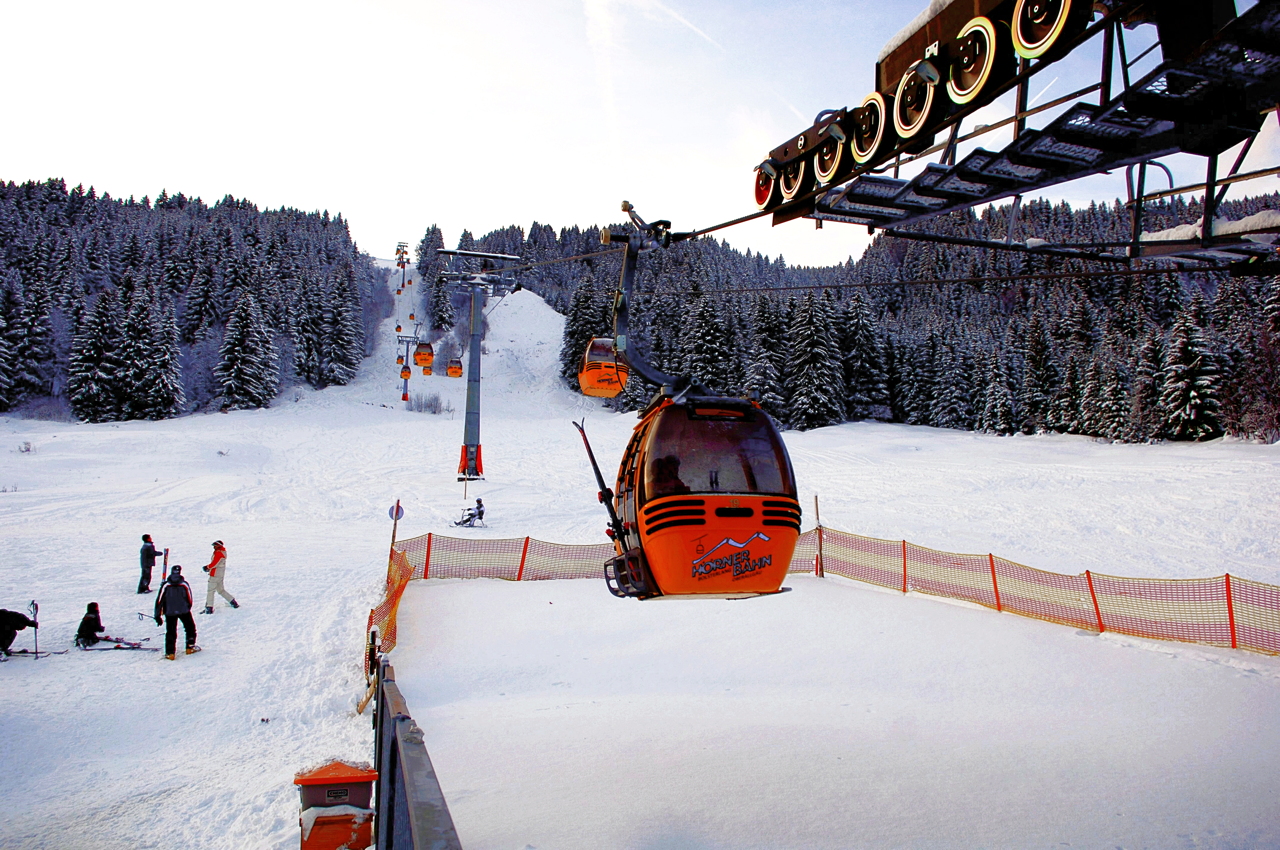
[417,195,1280,442]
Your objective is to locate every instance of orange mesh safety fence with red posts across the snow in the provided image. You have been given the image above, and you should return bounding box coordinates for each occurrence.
[369,527,1280,654]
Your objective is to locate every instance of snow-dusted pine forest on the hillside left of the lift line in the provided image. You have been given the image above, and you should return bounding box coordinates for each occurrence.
[0,179,392,422]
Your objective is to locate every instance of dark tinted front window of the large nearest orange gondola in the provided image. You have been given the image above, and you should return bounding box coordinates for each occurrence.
[644,406,795,502]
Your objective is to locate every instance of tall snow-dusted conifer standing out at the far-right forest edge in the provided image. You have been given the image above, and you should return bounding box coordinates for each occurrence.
[1160,309,1222,440]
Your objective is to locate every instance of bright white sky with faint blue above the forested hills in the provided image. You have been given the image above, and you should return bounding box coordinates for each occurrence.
[0,0,1280,265]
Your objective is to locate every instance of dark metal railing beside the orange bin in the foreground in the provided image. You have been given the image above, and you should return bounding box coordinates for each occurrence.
[374,658,462,850]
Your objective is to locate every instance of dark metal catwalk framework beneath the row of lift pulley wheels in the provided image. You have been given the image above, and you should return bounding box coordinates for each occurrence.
[757,0,1280,268]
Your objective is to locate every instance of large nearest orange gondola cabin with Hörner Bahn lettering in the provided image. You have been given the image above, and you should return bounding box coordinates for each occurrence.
[616,397,800,595]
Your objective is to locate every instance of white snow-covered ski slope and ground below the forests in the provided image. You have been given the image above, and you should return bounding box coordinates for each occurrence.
[0,262,1280,850]
